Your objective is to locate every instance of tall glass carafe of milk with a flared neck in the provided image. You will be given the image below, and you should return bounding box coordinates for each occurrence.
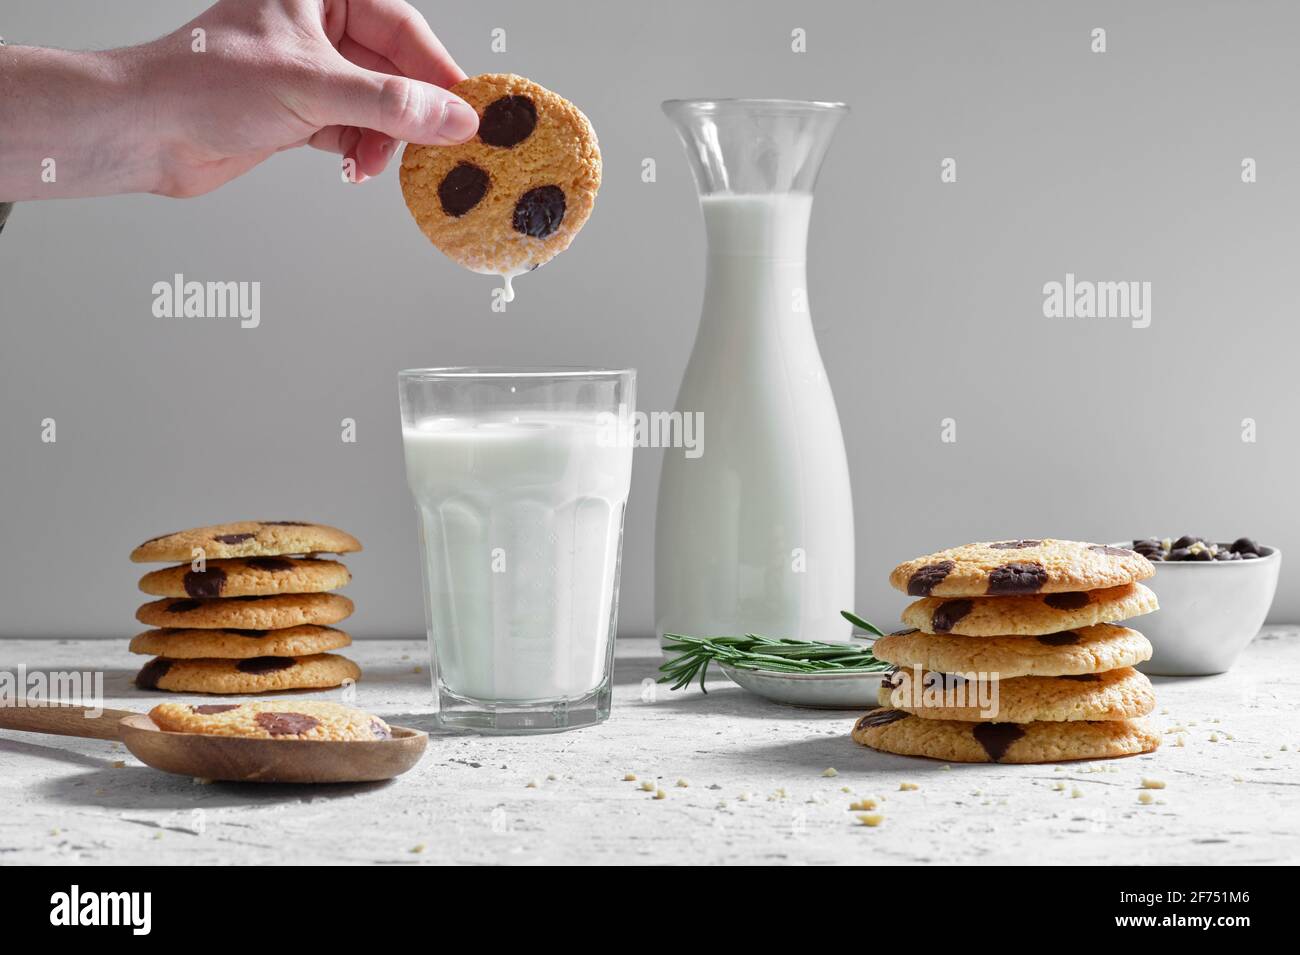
[655,100,854,641]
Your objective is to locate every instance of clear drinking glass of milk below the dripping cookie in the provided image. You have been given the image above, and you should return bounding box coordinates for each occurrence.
[398,368,636,733]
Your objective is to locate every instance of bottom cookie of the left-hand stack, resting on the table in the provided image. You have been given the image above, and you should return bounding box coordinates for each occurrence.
[135,654,361,694]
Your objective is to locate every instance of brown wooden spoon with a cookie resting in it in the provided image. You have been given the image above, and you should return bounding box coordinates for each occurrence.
[0,704,429,782]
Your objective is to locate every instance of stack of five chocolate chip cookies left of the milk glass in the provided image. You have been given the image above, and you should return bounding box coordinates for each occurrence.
[131,521,361,694]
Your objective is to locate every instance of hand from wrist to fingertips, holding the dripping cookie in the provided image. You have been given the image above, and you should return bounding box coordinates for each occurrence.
[140,0,478,196]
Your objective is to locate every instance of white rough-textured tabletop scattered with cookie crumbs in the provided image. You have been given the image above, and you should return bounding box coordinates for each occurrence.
[0,628,1300,864]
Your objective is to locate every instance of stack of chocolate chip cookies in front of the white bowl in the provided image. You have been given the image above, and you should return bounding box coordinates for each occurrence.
[853,539,1160,763]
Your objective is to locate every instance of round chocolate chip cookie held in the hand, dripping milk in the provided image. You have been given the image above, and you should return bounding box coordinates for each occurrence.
[400,73,601,288]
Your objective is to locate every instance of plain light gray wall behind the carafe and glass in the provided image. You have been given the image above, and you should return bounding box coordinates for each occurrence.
[0,0,1300,637]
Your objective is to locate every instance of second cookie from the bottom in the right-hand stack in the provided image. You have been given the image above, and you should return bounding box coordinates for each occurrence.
[879,667,1156,722]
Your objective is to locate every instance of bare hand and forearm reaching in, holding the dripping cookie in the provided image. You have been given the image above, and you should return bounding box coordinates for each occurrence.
[0,0,478,200]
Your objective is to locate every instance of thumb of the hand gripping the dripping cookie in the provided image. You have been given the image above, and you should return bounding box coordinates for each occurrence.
[313,66,478,146]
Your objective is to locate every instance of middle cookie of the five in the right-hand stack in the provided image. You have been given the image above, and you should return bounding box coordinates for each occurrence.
[871,624,1151,680]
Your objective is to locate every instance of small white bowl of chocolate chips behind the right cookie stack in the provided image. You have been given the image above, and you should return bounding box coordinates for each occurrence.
[1115,541,1282,677]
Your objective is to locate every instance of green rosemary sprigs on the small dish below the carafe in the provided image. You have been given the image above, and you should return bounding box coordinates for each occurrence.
[659,611,889,693]
